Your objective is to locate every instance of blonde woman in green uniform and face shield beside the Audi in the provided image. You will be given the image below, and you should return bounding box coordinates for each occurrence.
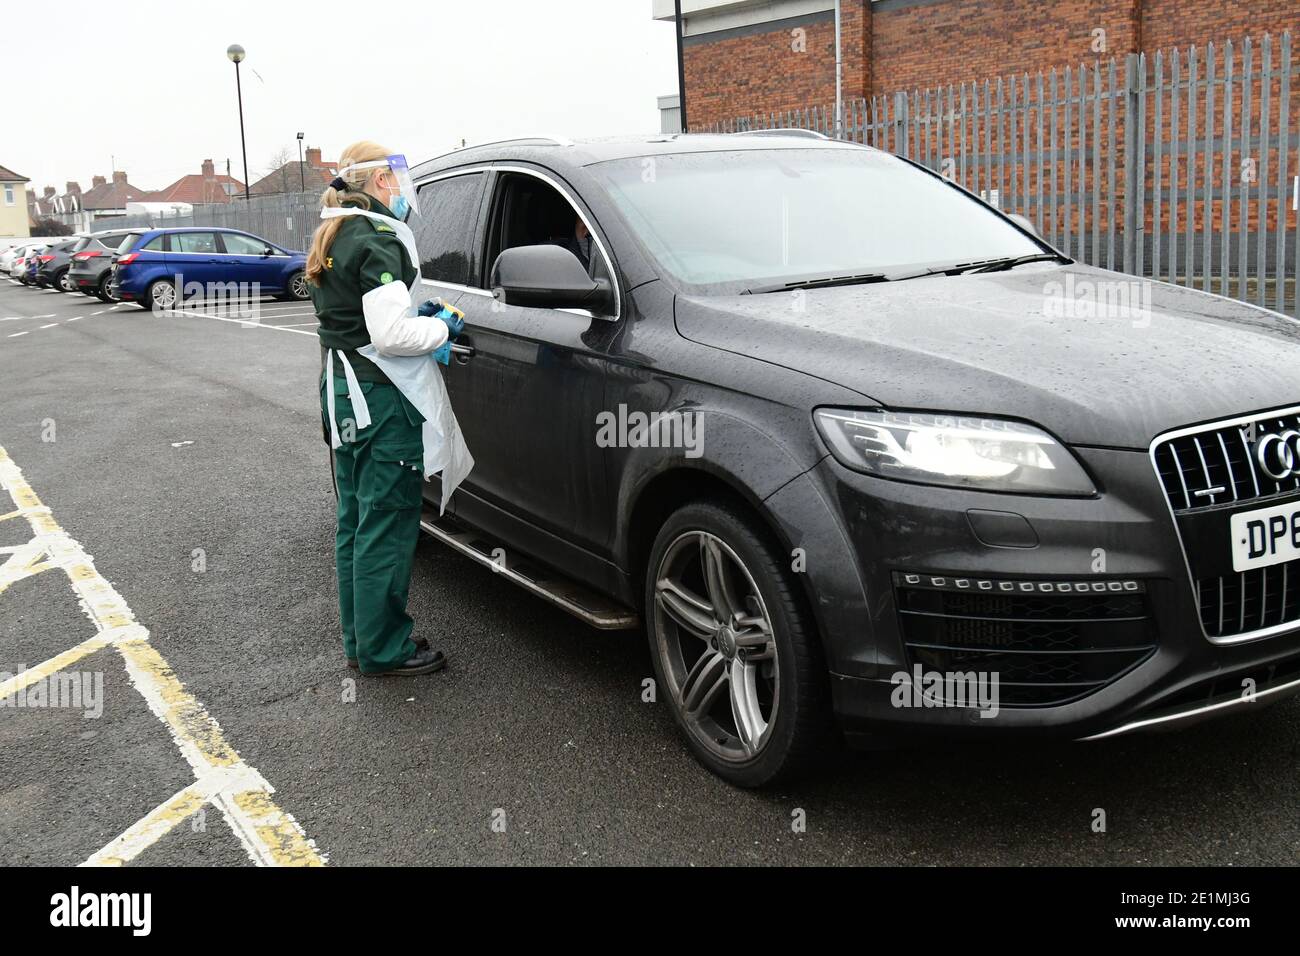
[307,142,463,675]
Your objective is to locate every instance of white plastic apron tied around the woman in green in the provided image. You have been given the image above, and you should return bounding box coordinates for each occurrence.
[321,206,475,514]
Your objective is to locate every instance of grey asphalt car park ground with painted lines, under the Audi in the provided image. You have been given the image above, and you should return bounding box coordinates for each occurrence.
[0,281,1300,865]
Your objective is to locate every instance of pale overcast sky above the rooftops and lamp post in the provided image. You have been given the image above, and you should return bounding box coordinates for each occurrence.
[0,0,677,193]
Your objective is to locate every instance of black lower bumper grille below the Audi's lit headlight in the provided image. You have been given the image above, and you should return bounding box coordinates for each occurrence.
[894,574,1156,706]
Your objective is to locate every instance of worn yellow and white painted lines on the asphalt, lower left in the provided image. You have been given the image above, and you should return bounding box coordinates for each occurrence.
[0,446,325,866]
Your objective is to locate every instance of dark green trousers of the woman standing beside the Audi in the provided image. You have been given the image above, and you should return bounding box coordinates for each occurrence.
[321,375,424,674]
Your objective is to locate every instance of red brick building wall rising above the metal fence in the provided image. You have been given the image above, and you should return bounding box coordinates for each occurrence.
[654,0,1300,127]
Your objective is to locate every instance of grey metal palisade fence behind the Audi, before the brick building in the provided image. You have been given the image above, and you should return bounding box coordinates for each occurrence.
[707,33,1300,317]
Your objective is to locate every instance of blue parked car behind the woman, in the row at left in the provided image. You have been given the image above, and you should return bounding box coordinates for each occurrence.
[113,228,308,310]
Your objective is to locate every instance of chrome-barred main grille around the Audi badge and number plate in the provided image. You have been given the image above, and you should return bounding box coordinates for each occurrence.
[1152,408,1300,643]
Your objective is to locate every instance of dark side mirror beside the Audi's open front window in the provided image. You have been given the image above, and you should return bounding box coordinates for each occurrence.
[490,245,615,316]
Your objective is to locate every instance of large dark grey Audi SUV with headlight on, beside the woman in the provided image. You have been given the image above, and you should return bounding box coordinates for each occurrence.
[379,134,1300,786]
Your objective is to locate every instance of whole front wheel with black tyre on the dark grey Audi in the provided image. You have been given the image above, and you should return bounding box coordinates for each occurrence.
[644,501,837,787]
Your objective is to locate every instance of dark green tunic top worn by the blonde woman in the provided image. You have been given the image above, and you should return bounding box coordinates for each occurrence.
[307,196,416,382]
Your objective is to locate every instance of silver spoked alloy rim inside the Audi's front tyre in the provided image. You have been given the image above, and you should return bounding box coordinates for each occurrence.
[654,531,780,762]
